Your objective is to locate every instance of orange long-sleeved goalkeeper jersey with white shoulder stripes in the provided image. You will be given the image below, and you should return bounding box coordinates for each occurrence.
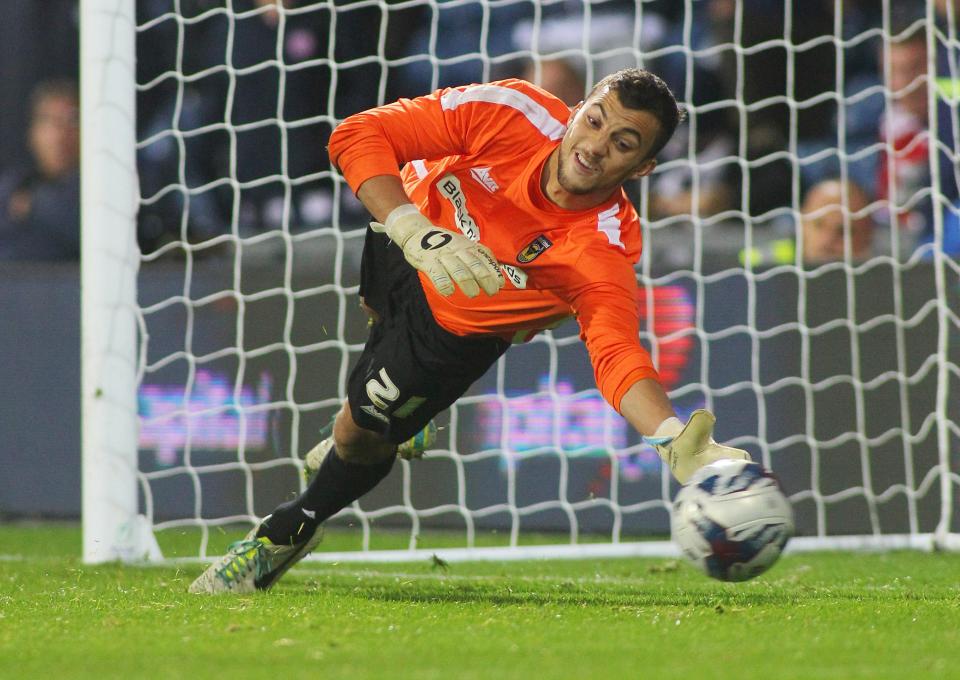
[329,79,657,410]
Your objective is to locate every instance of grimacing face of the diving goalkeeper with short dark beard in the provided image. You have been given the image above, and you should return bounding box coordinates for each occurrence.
[557,88,660,201]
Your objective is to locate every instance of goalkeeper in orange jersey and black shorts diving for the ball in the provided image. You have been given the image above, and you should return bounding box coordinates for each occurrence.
[190,69,748,592]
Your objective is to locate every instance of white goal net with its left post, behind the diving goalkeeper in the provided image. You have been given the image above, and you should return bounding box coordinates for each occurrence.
[82,0,960,561]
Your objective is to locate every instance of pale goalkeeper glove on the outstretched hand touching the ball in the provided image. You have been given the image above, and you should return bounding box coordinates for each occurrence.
[643,409,750,484]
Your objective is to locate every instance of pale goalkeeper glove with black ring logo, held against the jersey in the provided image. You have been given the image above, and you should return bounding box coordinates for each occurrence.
[370,203,504,297]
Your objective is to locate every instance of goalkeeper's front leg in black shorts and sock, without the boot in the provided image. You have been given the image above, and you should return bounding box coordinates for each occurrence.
[258,283,507,556]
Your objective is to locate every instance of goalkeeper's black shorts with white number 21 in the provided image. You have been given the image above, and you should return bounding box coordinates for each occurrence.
[347,229,510,444]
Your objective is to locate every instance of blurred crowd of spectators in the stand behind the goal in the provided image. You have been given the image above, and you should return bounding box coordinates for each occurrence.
[0,0,960,266]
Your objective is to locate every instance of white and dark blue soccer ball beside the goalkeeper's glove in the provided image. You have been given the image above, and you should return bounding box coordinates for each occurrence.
[672,460,793,581]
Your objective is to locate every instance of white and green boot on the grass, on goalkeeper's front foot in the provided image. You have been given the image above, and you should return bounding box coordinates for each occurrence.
[190,515,323,594]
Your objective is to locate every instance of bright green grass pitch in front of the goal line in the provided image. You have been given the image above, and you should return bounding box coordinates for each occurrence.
[0,525,960,680]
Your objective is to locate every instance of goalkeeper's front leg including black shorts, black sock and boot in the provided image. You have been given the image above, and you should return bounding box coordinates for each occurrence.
[190,226,508,592]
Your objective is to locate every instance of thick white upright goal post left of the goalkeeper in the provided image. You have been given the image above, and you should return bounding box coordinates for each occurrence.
[80,0,152,563]
